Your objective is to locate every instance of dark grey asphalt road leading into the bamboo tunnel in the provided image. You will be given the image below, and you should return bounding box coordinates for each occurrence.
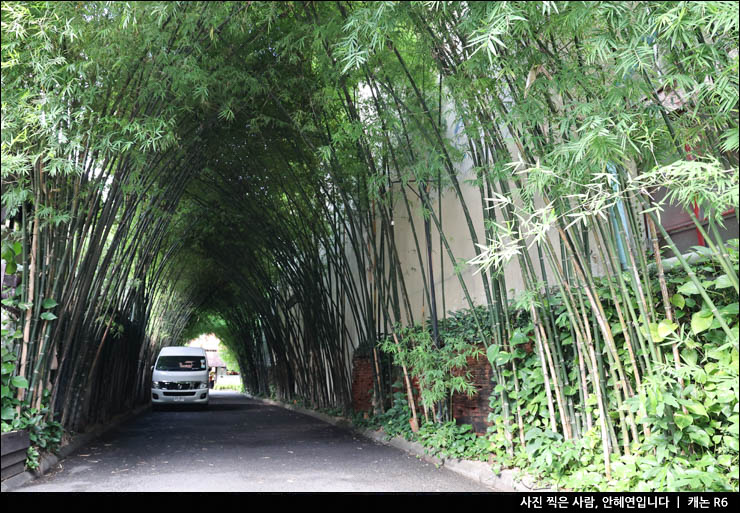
[17,392,494,492]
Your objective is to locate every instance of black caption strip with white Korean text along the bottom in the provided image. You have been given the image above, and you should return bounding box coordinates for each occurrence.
[3,490,740,513]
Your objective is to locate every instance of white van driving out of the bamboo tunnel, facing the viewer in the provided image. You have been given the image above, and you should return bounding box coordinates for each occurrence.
[152,347,208,409]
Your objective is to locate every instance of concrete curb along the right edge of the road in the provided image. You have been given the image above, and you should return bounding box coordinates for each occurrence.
[249,394,557,493]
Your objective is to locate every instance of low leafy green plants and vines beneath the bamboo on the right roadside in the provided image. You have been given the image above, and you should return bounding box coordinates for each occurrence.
[372,240,740,491]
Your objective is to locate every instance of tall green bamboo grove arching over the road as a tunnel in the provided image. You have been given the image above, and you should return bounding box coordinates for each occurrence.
[2,2,738,489]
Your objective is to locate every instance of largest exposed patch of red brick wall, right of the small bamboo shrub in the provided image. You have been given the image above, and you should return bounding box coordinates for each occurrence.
[452,348,493,433]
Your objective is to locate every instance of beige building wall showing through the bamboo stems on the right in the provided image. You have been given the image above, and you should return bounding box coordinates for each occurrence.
[346,94,620,356]
